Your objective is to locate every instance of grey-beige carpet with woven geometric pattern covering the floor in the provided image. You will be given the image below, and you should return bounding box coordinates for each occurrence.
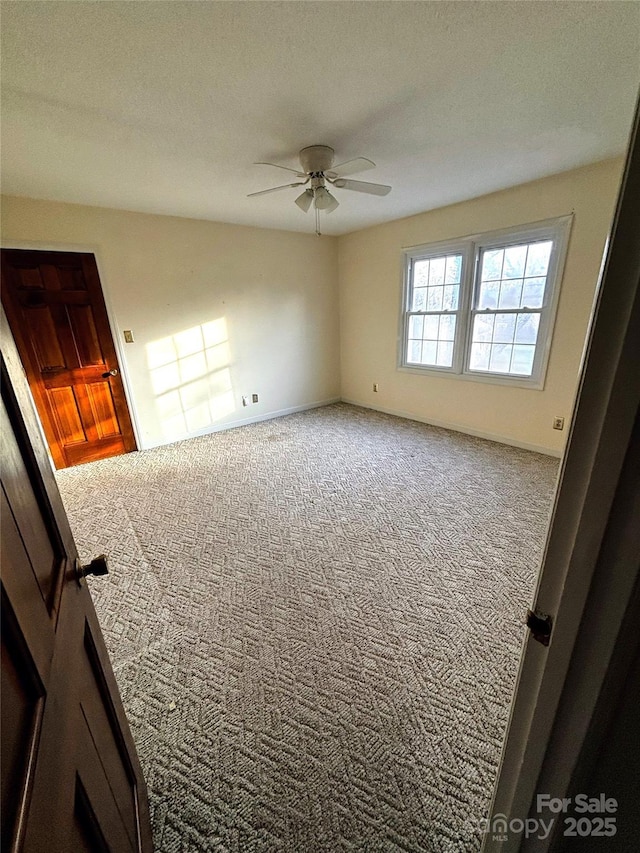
[58,404,557,853]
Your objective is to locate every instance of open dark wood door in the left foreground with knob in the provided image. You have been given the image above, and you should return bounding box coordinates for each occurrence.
[0,314,152,853]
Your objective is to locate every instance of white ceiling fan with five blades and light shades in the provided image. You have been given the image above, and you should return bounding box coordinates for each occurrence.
[247,145,391,236]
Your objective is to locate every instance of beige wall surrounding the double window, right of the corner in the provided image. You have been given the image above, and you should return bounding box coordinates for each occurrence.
[339,159,623,454]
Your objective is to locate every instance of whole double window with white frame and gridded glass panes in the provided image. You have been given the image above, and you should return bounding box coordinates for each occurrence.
[400,216,571,388]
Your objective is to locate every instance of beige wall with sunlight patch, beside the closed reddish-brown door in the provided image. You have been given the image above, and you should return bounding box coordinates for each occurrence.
[2,197,340,447]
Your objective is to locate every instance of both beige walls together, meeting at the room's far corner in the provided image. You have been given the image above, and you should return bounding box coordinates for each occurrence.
[2,159,623,454]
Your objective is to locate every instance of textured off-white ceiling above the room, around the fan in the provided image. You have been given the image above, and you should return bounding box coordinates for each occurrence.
[2,0,640,234]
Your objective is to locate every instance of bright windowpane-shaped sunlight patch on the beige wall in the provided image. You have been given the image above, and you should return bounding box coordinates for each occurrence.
[147,317,236,440]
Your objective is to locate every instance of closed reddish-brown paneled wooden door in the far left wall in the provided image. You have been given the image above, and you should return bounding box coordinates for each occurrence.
[2,249,136,468]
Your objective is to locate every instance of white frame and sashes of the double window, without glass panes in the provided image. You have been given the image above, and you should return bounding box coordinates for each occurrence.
[398,214,573,390]
